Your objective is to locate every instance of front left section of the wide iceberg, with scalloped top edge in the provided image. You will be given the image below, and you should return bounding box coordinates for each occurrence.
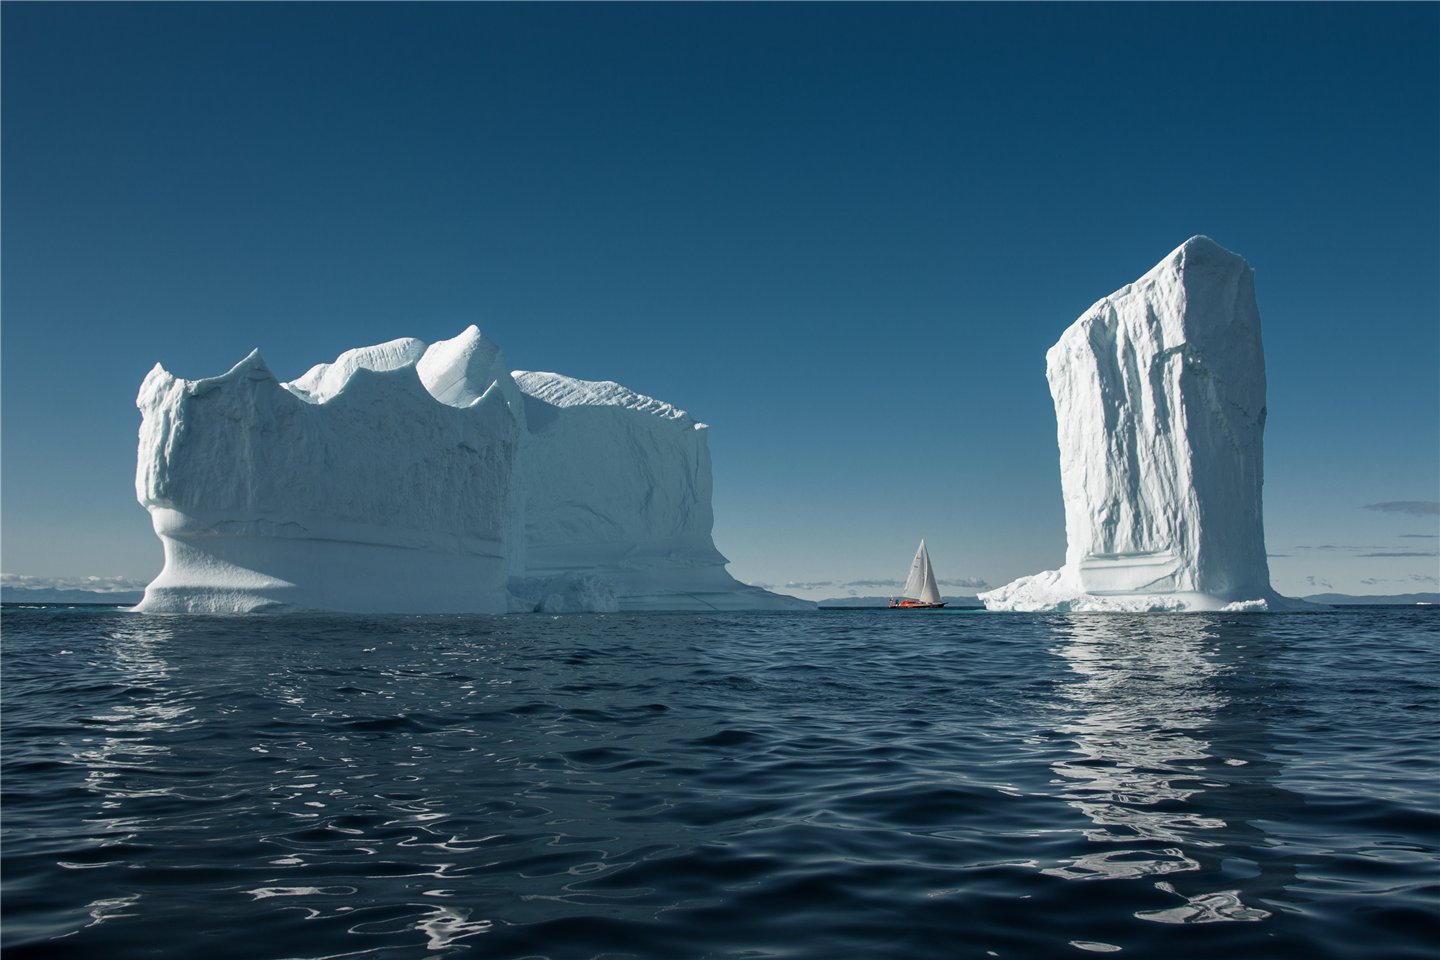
[135,328,520,613]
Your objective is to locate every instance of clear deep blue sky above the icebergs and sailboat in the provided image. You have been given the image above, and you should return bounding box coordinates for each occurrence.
[0,3,1440,597]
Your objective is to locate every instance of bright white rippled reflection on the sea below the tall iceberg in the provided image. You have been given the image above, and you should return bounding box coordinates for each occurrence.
[1043,616,1270,923]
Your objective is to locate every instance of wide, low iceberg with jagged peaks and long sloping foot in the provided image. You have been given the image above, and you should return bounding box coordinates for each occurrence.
[135,327,809,613]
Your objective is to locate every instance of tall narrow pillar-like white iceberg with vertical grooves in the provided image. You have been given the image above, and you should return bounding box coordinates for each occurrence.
[979,236,1297,612]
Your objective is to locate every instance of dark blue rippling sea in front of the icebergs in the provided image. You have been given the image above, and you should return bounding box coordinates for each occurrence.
[0,607,1440,960]
